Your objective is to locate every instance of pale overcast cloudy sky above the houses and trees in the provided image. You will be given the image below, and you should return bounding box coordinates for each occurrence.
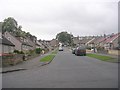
[0,0,118,40]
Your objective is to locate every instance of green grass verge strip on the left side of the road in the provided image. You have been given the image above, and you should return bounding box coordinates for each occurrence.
[40,50,58,62]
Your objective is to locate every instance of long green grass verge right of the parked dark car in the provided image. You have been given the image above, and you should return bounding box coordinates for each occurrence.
[87,53,118,63]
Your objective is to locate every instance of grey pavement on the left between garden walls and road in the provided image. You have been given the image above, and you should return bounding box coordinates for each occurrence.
[0,52,51,73]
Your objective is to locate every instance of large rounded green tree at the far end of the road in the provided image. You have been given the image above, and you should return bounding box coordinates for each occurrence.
[56,32,73,45]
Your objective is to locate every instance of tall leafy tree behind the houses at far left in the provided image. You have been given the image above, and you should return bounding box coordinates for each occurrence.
[2,17,18,33]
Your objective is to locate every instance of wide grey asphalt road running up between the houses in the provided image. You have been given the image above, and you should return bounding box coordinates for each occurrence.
[2,48,118,88]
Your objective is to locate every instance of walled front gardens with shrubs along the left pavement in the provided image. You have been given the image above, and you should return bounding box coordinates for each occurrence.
[0,48,49,67]
